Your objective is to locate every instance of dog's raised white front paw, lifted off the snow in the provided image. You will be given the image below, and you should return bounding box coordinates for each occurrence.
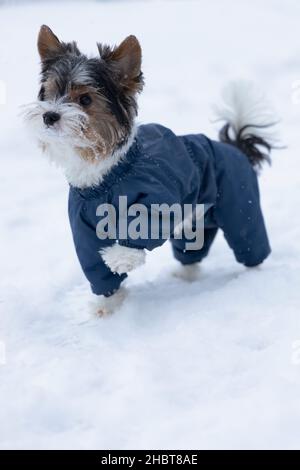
[100,243,146,274]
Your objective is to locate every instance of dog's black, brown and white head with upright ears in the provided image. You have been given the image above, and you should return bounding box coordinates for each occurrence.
[27,26,143,161]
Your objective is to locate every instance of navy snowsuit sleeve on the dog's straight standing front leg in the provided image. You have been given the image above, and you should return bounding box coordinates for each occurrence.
[69,196,127,297]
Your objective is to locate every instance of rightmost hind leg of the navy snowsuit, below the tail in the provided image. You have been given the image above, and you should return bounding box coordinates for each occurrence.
[215,144,271,267]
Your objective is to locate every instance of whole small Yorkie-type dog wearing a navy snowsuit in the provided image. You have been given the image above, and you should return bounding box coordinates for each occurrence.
[26,26,276,315]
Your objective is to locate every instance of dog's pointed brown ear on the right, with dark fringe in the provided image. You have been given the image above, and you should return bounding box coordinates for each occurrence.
[98,36,143,92]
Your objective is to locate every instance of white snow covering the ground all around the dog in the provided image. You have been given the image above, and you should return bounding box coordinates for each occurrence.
[0,0,300,449]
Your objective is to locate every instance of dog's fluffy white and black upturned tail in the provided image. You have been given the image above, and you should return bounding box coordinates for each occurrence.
[214,80,279,168]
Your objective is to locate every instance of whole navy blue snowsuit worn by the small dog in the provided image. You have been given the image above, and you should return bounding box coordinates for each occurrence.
[69,124,271,296]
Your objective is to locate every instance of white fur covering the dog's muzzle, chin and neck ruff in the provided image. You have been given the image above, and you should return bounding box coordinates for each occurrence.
[23,100,137,189]
